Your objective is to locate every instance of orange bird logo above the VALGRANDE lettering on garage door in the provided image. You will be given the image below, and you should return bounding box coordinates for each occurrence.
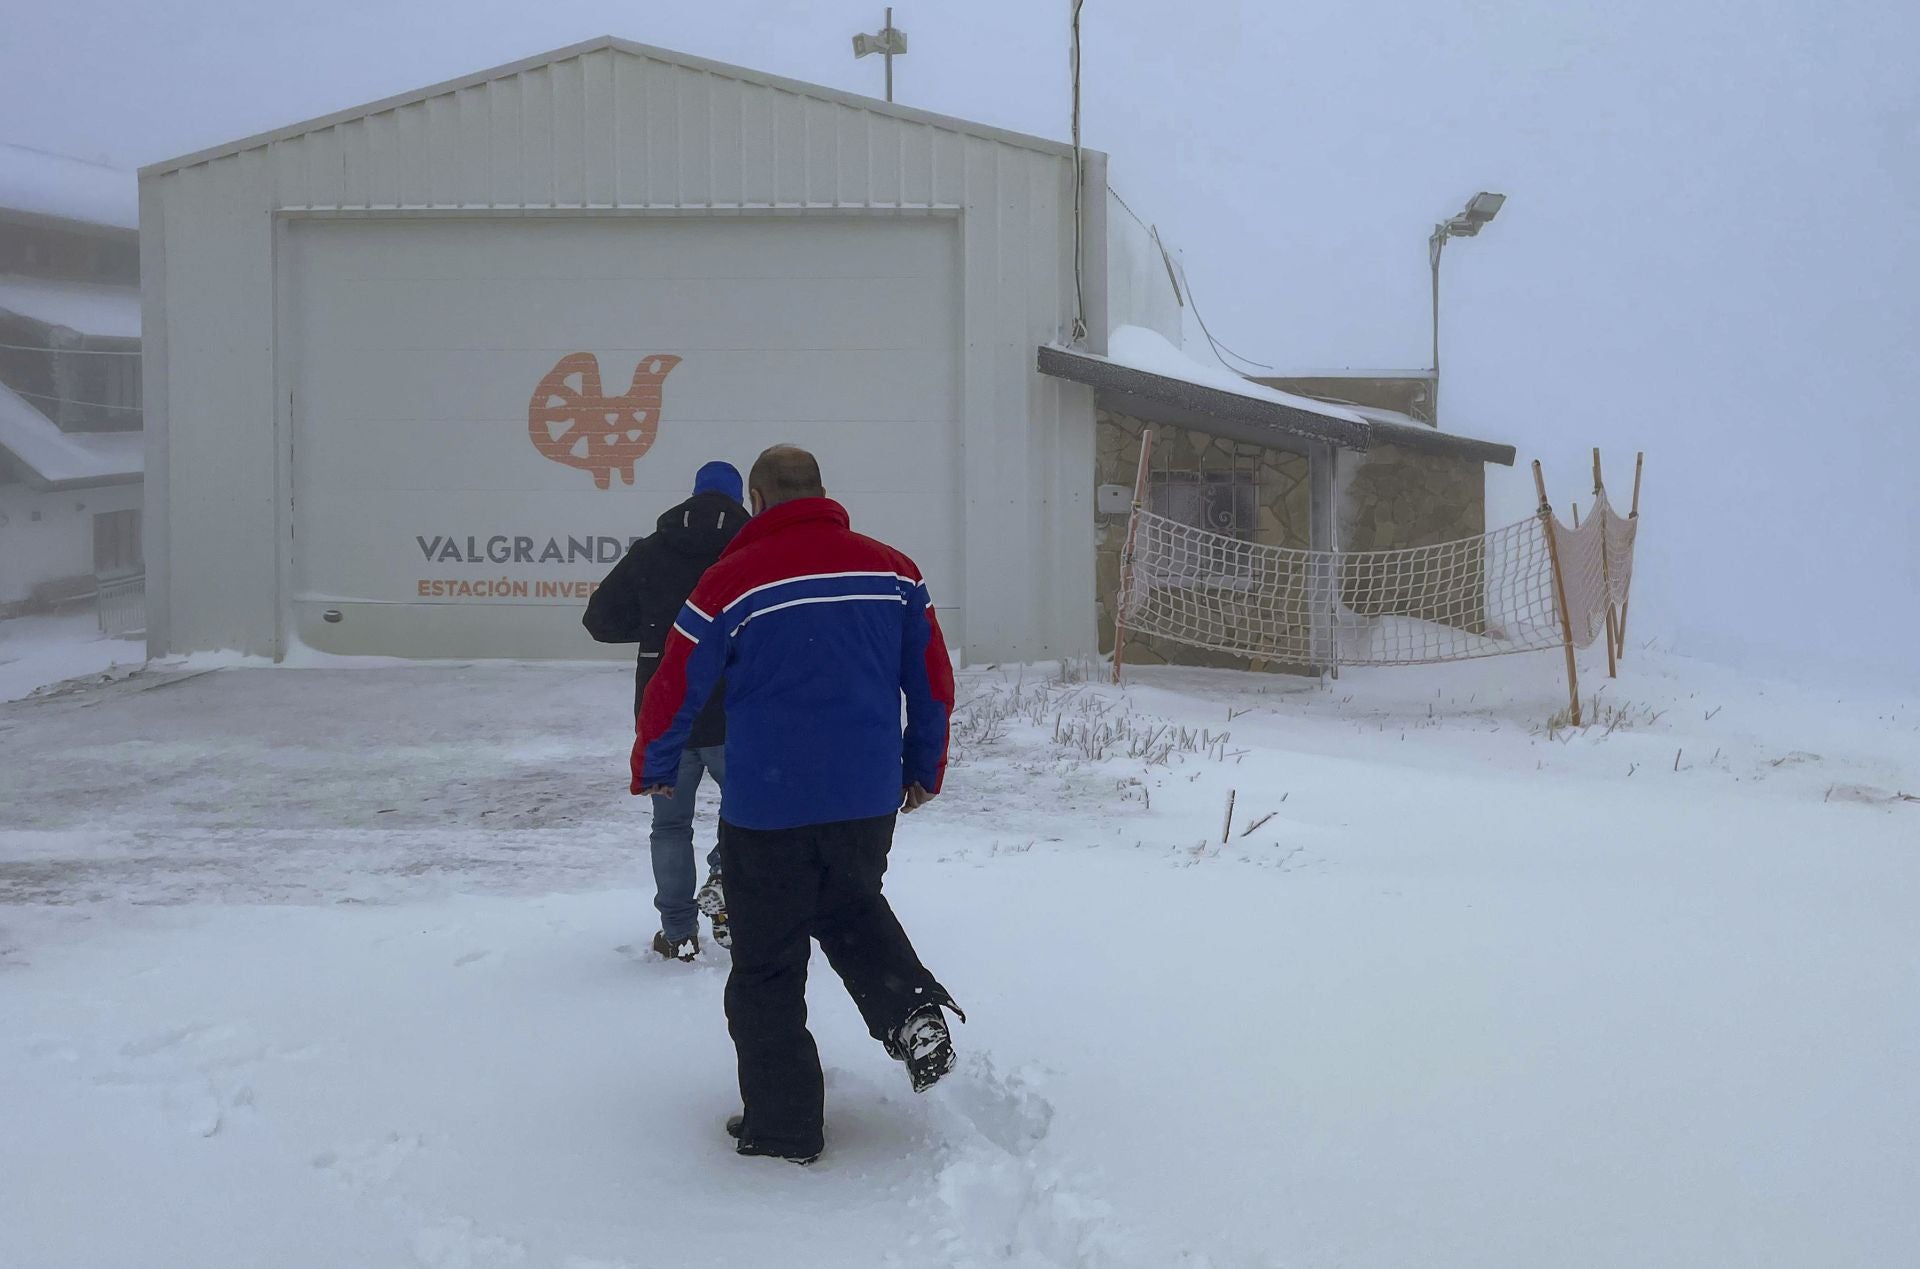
[526,353,680,490]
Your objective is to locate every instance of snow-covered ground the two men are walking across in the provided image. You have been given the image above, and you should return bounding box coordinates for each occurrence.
[0,651,1920,1269]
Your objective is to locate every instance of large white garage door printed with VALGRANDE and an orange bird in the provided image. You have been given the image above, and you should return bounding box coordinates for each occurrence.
[286,217,962,657]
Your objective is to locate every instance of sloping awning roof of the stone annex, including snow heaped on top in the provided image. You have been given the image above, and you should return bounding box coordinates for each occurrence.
[1039,326,1515,467]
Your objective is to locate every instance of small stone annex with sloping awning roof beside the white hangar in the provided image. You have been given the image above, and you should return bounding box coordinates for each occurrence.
[1041,335,1515,674]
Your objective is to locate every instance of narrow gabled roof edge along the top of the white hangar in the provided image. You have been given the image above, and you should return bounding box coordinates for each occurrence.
[140,35,1073,179]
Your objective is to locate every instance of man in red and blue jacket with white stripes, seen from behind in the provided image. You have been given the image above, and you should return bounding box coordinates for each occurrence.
[634,445,960,1163]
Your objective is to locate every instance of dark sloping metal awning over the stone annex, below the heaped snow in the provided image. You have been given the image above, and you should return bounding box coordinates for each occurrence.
[1039,344,1515,467]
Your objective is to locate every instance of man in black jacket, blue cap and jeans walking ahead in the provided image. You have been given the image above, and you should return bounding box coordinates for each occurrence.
[580,463,747,960]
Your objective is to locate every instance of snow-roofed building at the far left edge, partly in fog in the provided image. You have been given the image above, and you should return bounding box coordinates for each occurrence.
[0,144,144,624]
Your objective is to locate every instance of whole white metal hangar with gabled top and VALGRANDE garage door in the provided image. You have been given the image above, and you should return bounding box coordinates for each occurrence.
[140,38,1121,660]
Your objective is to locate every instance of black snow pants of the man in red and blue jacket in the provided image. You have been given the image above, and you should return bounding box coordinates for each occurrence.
[720,816,947,1156]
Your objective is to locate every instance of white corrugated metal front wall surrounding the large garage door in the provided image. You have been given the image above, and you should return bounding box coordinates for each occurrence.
[140,42,1106,660]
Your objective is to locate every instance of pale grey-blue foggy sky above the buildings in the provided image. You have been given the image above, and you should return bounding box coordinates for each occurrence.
[0,0,1920,683]
